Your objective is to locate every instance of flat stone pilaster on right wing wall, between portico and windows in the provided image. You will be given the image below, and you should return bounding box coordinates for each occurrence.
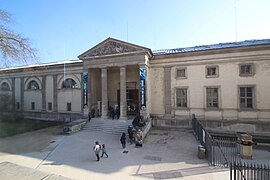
[164,67,172,116]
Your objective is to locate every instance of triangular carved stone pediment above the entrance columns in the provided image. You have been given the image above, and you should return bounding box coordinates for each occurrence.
[78,38,151,59]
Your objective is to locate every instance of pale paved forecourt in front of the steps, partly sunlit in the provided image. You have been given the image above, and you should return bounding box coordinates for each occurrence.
[0,119,232,180]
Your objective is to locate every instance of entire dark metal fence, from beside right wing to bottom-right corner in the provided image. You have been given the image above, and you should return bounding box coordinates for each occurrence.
[192,115,270,180]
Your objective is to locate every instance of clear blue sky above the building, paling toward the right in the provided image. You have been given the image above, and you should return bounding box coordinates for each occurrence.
[0,0,270,66]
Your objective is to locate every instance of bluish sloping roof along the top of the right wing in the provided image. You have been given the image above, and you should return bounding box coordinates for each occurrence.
[153,39,270,56]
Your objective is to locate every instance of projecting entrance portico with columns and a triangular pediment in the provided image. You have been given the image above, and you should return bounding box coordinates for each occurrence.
[79,38,152,119]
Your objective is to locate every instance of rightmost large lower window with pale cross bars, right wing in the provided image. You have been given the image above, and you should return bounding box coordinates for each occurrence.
[239,87,254,109]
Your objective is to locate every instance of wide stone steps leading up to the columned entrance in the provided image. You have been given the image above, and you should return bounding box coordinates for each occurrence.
[81,118,133,135]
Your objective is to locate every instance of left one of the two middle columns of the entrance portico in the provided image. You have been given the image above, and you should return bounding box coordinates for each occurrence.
[101,68,108,119]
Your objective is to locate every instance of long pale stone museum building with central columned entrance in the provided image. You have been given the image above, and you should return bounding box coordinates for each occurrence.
[0,38,270,132]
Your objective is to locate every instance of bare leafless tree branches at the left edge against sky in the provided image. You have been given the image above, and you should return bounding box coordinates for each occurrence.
[0,9,36,66]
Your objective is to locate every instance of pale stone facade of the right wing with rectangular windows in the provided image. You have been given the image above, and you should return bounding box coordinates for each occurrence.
[149,44,270,132]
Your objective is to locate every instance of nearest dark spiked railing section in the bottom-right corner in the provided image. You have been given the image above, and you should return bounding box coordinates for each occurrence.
[230,162,270,180]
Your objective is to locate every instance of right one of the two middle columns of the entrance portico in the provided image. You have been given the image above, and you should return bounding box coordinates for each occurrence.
[120,67,127,119]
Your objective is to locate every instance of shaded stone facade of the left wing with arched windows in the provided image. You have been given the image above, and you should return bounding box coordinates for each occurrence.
[0,61,82,121]
